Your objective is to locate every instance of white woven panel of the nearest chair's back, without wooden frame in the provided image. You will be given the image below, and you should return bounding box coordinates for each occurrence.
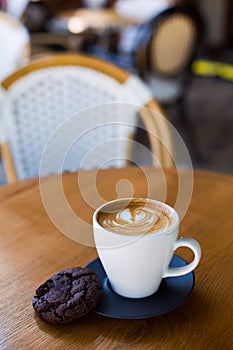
[1,56,160,179]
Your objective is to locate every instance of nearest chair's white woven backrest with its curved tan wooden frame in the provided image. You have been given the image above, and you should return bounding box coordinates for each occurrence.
[2,54,171,181]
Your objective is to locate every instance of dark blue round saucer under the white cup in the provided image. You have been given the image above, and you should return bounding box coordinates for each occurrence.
[87,255,195,319]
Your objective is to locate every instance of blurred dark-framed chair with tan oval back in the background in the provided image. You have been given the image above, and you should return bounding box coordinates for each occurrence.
[136,6,204,156]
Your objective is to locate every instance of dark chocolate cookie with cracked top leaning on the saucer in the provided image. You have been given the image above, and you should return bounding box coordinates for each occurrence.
[32,267,102,324]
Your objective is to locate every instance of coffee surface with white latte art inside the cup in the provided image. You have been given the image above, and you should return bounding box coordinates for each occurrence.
[98,199,173,236]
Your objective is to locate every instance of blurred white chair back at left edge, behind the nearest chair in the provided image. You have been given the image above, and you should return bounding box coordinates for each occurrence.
[0,11,30,81]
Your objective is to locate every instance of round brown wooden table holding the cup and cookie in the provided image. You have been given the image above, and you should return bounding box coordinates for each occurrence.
[0,167,233,350]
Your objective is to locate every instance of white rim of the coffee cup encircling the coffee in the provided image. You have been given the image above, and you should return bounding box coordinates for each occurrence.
[93,197,180,239]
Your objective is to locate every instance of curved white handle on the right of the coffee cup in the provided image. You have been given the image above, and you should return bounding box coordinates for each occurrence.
[163,237,201,277]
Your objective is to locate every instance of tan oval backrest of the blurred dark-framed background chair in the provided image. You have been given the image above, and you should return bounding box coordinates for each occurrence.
[137,6,203,78]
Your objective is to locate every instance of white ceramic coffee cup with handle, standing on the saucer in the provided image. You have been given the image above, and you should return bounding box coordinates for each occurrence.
[93,198,201,298]
